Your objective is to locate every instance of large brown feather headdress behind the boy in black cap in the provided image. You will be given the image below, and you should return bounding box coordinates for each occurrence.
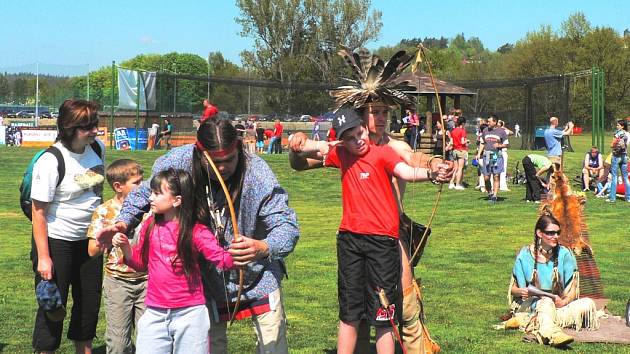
[330,47,415,111]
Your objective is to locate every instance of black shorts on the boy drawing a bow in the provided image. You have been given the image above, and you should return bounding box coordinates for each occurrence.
[337,231,400,327]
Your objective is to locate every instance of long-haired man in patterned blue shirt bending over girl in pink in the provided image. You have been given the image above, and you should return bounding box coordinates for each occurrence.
[97,119,299,353]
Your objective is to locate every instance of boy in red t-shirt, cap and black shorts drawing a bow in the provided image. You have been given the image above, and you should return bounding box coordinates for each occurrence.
[294,109,450,352]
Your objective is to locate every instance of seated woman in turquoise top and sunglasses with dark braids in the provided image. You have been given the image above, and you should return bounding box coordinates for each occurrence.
[504,215,599,347]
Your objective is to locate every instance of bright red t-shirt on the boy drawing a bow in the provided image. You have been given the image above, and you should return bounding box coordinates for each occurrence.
[324,143,402,238]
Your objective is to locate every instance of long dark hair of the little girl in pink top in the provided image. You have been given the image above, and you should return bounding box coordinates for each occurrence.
[141,168,197,276]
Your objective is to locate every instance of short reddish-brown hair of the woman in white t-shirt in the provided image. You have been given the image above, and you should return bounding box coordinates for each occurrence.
[57,100,98,147]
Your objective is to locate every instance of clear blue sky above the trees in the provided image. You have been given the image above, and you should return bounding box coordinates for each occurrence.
[0,0,630,75]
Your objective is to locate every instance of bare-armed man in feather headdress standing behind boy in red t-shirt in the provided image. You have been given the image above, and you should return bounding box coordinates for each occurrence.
[289,48,453,354]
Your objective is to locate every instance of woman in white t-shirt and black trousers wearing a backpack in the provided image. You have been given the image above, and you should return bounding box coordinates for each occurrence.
[31,100,105,353]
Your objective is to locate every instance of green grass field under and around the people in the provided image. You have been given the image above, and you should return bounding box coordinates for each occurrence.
[0,136,630,353]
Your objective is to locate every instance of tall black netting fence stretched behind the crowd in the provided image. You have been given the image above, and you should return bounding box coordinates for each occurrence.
[0,65,588,149]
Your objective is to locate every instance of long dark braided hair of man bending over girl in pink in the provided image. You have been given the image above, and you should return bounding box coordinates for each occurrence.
[192,119,248,232]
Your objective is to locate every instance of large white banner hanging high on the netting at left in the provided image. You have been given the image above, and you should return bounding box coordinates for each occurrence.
[118,68,156,111]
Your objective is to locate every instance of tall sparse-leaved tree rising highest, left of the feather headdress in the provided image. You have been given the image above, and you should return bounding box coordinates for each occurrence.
[237,0,382,112]
